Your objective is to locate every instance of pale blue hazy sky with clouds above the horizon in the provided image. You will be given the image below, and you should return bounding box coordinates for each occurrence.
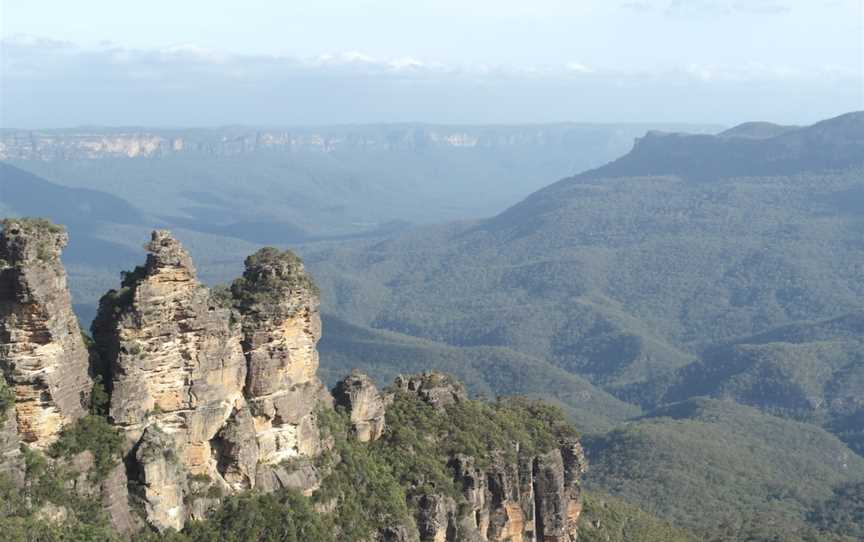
[0,0,864,128]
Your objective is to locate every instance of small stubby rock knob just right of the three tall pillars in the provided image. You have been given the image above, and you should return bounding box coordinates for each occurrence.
[333,371,385,442]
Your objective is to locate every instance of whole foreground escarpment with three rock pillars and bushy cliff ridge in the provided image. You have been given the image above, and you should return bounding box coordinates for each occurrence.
[0,221,585,542]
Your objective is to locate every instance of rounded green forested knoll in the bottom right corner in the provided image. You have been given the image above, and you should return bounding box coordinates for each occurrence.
[584,399,864,541]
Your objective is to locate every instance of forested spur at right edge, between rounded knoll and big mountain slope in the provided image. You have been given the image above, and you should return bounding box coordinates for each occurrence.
[626,311,864,453]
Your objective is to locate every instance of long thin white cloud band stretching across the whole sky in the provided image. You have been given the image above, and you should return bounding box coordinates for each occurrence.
[0,36,862,84]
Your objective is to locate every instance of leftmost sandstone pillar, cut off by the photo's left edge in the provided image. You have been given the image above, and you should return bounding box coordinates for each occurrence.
[0,219,92,449]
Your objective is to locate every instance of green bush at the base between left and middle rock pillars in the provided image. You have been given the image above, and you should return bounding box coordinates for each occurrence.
[48,414,123,480]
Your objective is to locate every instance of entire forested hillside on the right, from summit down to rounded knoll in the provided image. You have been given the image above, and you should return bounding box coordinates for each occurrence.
[296,114,864,542]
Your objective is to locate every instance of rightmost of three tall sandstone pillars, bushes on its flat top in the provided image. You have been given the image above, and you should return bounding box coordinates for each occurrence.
[231,248,332,491]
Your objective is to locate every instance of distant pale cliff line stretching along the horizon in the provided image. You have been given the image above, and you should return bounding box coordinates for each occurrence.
[0,123,720,160]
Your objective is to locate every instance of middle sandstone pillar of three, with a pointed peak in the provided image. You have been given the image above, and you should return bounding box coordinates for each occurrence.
[93,231,246,481]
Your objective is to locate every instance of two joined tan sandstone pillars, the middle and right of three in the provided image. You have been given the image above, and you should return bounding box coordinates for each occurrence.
[93,235,329,530]
